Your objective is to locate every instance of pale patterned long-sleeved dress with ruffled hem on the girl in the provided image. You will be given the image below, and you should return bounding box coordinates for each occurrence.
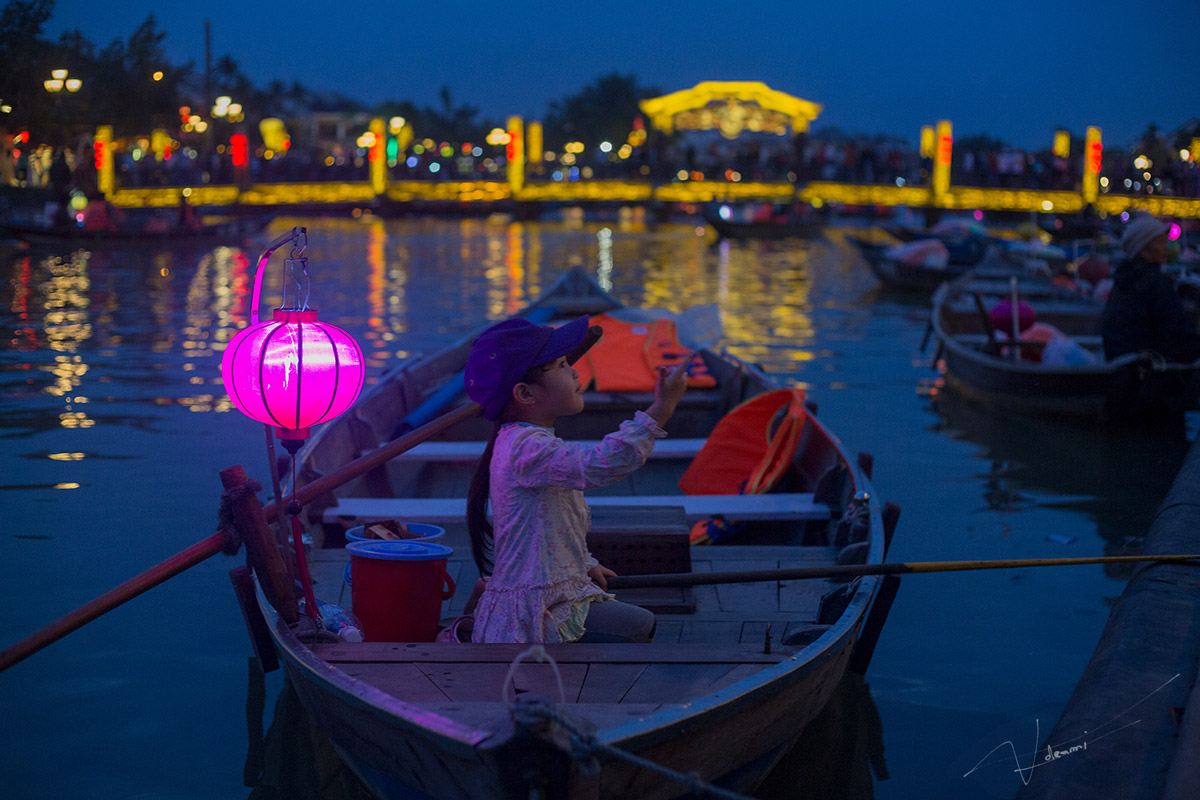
[472,411,666,643]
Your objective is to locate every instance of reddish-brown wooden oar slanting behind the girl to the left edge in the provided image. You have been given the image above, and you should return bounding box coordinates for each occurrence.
[0,403,479,672]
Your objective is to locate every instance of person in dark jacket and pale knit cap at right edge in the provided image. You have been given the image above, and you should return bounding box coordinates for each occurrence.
[1100,216,1200,417]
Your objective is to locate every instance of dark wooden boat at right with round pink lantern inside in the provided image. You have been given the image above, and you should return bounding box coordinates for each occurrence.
[931,272,1195,422]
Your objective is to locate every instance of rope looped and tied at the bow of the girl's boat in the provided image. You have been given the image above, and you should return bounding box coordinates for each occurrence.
[502,644,754,800]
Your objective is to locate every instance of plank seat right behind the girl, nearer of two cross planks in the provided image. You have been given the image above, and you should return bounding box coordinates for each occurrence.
[324,493,829,525]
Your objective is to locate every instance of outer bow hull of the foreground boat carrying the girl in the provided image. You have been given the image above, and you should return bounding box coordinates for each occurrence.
[268,607,865,800]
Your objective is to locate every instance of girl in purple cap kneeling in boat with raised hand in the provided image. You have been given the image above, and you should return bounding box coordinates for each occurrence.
[464,317,690,642]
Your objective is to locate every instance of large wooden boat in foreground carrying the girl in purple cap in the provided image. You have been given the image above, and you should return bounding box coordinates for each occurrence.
[243,270,899,799]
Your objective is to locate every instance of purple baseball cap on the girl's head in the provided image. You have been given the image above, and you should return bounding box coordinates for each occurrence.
[463,317,600,420]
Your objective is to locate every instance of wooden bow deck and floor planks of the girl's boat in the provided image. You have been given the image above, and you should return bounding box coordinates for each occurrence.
[310,546,835,727]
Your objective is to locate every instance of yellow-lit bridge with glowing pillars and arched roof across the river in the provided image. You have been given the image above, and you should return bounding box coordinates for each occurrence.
[96,82,1200,218]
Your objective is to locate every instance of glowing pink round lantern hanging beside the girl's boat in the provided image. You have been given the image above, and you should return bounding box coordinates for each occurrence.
[221,308,365,452]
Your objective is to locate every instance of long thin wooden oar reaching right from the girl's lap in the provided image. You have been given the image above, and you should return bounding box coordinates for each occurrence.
[607,555,1200,590]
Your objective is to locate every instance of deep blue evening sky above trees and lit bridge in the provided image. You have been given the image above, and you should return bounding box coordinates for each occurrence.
[44,0,1200,149]
